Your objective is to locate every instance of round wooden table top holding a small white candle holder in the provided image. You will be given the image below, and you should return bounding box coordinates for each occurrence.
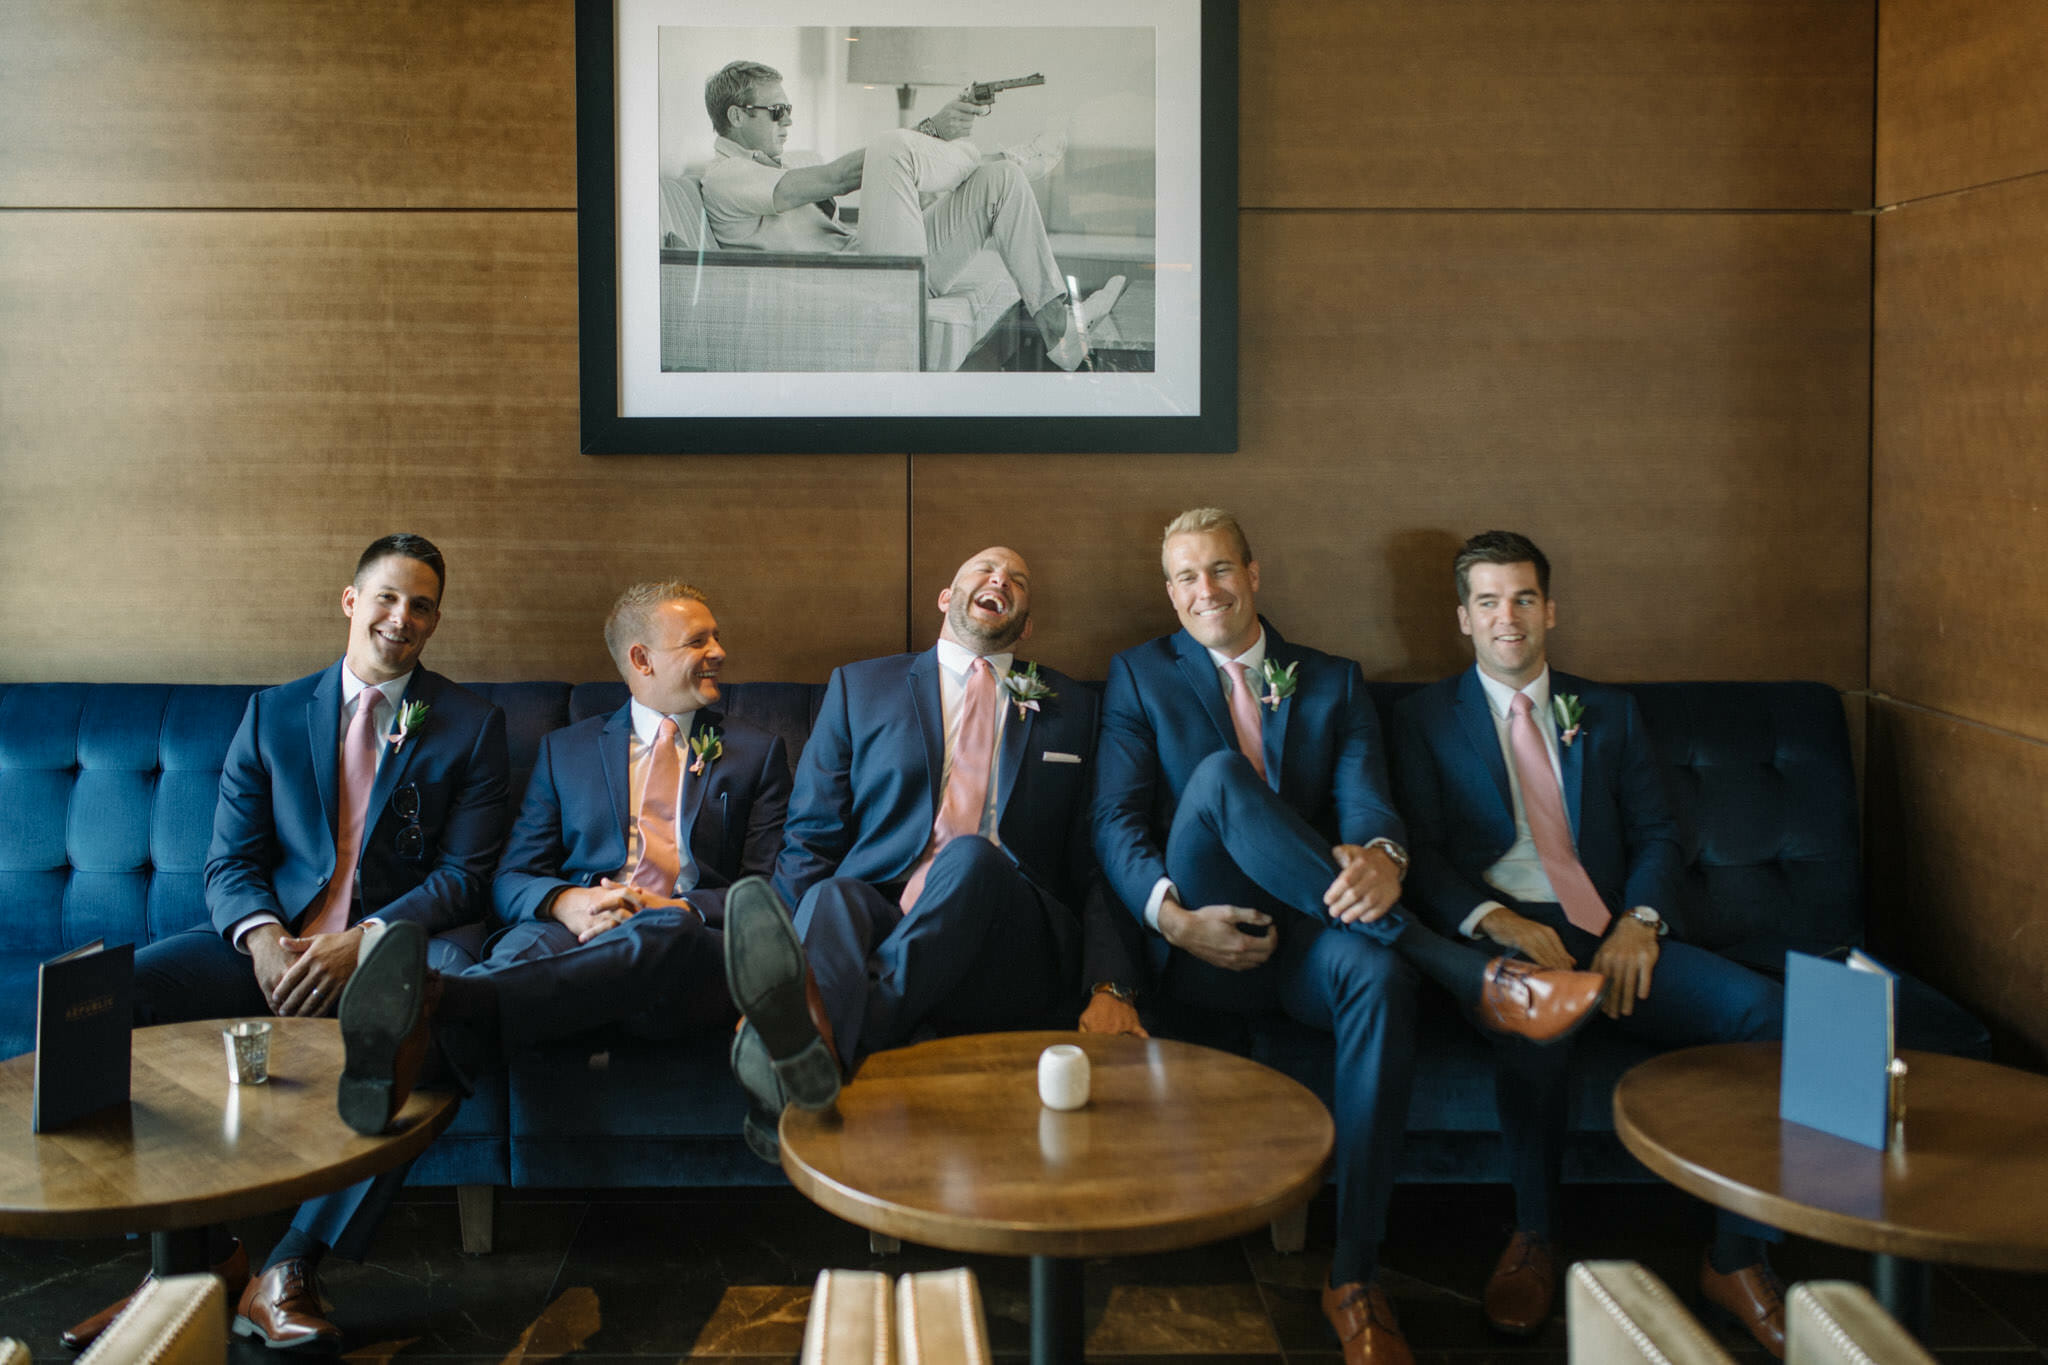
[780,1033,1335,1257]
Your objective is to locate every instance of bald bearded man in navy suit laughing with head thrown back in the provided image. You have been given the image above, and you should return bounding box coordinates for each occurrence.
[725,546,1096,1158]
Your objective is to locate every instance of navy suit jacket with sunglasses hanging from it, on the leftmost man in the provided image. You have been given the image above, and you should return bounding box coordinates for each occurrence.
[207,661,510,935]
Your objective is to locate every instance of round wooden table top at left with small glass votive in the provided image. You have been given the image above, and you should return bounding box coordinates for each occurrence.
[0,1019,459,1236]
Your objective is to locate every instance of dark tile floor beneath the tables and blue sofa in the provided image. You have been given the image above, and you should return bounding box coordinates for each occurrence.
[0,1185,2048,1365]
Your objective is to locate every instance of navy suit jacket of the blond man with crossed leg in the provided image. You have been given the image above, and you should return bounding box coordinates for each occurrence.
[1096,616,1407,941]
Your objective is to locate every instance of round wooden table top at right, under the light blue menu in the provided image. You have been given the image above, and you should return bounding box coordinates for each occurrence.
[1614,1044,2048,1271]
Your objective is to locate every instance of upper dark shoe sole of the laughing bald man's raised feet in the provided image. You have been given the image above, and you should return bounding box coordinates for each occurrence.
[725,878,840,1109]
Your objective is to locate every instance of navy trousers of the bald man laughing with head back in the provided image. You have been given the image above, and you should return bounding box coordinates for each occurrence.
[795,835,1079,1072]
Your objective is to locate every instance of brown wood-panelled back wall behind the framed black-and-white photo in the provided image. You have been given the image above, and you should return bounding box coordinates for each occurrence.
[0,0,1876,690]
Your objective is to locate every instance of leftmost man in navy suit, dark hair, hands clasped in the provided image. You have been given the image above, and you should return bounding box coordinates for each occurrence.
[86,534,508,1347]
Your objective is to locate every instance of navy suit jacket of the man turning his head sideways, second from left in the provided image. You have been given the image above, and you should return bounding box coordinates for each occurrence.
[492,702,788,925]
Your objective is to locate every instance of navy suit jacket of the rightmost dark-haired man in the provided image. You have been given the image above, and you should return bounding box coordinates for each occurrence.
[1393,665,1681,933]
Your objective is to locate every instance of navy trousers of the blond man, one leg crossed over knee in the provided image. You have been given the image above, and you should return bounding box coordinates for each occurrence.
[1165,751,1415,1283]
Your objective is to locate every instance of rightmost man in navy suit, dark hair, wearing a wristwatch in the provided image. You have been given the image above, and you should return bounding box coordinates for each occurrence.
[1393,530,1784,1355]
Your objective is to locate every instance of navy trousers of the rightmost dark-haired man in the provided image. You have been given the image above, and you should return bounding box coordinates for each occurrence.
[1487,896,1786,1240]
